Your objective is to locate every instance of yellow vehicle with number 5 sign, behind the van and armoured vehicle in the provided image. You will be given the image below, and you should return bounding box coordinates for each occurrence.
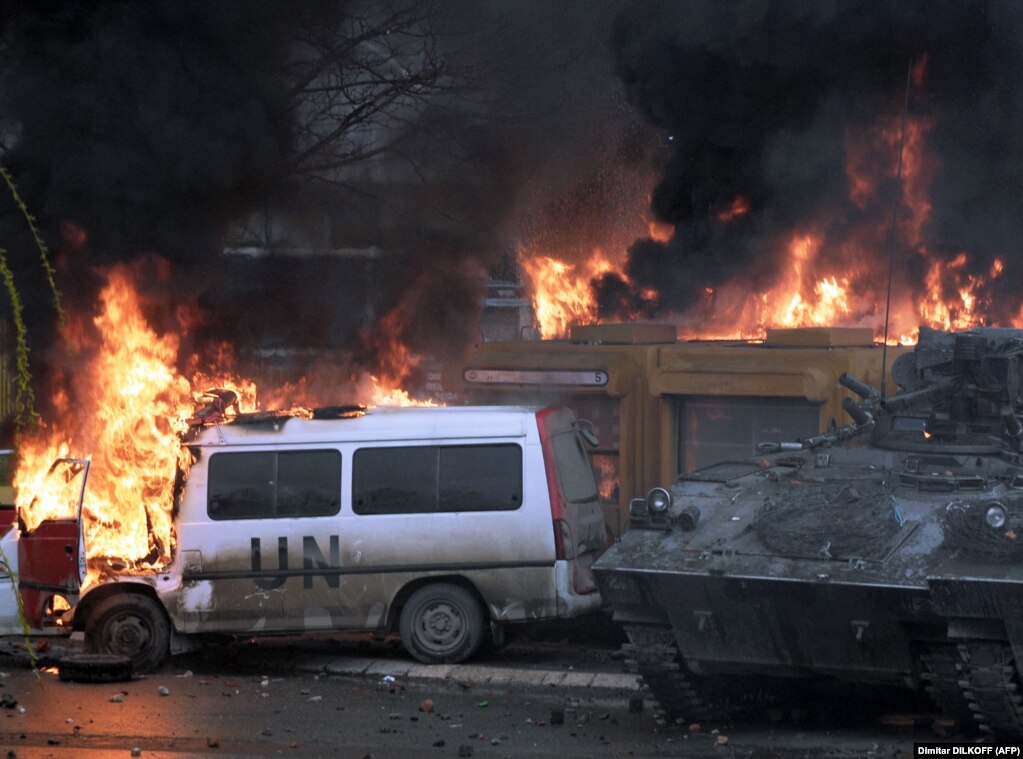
[445,323,905,534]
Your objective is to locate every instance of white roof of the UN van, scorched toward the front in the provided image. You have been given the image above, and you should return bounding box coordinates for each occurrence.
[188,406,541,447]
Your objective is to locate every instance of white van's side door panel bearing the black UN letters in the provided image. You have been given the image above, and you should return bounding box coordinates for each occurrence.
[171,448,342,632]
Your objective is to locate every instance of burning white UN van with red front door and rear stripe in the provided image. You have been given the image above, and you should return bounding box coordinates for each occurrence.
[2,407,609,671]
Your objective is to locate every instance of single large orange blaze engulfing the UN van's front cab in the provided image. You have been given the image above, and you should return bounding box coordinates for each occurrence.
[14,269,192,572]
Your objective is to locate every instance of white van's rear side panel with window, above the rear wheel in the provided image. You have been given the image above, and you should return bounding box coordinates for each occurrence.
[342,439,557,625]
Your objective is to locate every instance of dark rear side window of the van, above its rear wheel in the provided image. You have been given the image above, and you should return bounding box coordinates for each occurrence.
[352,444,522,515]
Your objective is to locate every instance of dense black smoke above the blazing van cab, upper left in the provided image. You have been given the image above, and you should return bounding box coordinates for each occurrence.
[0,0,292,374]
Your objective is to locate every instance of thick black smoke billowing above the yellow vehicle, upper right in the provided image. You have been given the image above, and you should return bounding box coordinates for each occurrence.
[598,0,1023,318]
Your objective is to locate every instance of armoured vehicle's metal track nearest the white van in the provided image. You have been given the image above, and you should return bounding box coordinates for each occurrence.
[622,625,723,721]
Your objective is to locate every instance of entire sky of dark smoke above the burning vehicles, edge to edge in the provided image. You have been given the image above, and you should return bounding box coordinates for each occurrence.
[0,0,1023,392]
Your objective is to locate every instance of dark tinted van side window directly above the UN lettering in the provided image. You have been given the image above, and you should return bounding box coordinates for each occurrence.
[207,450,341,520]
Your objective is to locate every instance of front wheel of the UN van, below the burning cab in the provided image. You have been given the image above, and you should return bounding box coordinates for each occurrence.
[85,593,171,672]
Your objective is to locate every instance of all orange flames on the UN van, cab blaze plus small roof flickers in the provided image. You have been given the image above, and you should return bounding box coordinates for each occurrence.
[14,267,427,582]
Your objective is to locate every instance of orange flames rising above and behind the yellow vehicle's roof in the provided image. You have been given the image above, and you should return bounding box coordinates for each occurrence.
[520,106,1023,343]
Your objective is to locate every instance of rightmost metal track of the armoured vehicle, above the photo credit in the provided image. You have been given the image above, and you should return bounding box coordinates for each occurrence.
[957,640,1023,740]
